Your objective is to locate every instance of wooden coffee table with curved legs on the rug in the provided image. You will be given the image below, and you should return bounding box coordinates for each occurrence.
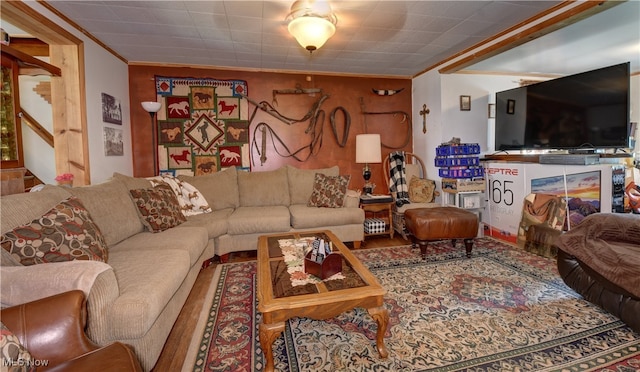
[257,231,389,371]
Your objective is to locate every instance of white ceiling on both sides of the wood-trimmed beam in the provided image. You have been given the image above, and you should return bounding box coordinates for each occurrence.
[3,0,640,77]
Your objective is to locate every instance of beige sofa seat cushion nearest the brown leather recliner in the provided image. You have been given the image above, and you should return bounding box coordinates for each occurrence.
[105,247,190,340]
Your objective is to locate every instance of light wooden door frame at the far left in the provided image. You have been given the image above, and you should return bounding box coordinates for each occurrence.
[0,1,91,186]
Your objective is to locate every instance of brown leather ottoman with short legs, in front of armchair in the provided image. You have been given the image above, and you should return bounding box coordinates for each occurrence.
[404,207,479,260]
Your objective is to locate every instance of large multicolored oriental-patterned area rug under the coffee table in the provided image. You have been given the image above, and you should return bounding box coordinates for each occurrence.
[183,238,640,371]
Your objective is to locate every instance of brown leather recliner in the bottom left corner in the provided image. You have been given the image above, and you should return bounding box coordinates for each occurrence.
[0,291,142,372]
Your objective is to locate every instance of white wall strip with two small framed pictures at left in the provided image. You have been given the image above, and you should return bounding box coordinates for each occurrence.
[25,1,133,184]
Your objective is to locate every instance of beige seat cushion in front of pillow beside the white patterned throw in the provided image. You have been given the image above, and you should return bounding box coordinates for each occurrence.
[109,225,209,266]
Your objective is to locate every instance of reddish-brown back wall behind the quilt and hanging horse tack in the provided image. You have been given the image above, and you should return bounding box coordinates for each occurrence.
[129,64,413,193]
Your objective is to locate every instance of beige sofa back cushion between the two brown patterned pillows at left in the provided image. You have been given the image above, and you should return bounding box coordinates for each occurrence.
[68,179,144,246]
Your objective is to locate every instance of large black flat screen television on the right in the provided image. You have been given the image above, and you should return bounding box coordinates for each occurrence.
[495,62,630,151]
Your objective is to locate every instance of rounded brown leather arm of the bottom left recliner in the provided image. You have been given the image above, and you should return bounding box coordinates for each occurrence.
[0,291,99,366]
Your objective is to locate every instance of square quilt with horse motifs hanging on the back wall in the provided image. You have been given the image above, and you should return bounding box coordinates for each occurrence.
[155,76,251,175]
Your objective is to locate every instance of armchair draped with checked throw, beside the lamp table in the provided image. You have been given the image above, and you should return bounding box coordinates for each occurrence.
[382,152,440,240]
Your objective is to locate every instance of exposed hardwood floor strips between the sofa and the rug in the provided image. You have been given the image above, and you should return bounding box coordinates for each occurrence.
[153,234,410,372]
